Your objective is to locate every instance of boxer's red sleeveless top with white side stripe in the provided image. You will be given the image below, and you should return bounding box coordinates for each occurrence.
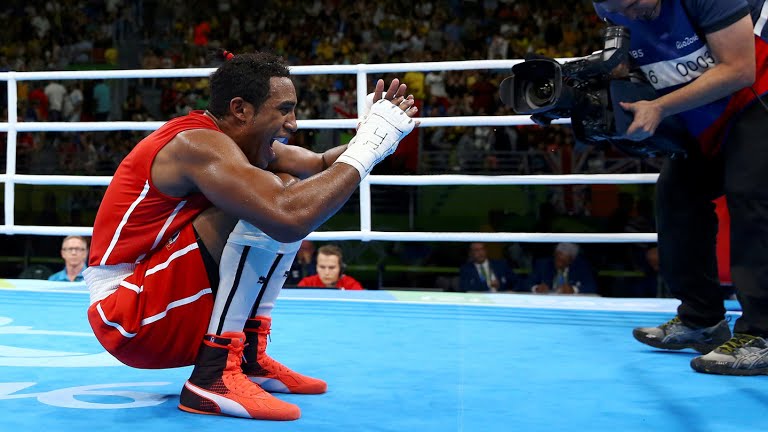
[88,111,220,266]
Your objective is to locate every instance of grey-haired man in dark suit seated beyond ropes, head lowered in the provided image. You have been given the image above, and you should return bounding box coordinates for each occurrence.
[521,243,597,294]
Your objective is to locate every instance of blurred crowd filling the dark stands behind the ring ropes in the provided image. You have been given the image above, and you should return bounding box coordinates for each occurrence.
[0,0,657,296]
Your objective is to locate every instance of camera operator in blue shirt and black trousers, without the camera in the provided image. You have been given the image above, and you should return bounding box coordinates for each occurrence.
[594,0,768,375]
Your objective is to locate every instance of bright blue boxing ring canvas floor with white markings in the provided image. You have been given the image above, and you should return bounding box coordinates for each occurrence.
[0,279,768,432]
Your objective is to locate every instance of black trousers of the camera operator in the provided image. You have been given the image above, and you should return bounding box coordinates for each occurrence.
[656,103,768,336]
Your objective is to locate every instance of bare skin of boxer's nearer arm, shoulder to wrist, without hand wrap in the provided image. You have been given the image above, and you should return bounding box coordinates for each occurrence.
[176,129,360,243]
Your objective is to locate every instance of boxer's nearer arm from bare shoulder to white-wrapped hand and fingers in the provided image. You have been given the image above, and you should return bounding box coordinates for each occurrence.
[150,79,415,243]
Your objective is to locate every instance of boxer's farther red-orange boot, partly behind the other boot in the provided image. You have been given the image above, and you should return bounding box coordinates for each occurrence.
[243,316,328,394]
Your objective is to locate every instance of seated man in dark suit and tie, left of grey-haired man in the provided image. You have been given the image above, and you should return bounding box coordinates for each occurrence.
[459,243,517,292]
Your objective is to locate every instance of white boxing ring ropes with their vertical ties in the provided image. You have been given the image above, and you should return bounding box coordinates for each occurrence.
[0,58,658,243]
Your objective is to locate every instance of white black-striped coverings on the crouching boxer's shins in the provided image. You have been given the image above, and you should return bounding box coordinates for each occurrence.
[208,220,301,334]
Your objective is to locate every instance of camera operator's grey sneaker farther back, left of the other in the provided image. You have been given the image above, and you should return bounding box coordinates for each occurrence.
[632,317,731,354]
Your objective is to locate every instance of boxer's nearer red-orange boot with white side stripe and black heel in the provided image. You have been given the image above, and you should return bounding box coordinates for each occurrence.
[179,332,301,420]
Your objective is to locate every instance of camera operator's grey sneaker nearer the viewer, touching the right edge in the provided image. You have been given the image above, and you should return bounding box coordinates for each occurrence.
[691,333,768,375]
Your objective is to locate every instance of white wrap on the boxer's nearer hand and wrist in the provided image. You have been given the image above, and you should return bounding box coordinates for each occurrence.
[336,99,416,180]
